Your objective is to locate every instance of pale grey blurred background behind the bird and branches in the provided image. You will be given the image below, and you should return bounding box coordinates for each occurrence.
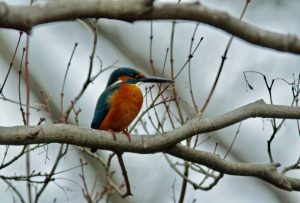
[0,0,300,203]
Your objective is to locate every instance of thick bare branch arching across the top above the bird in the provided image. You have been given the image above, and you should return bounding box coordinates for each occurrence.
[0,0,300,54]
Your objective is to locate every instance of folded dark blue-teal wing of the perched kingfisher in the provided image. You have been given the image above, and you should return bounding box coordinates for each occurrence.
[91,85,120,129]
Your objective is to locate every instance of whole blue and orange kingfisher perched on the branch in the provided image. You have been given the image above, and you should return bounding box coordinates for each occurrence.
[91,67,174,152]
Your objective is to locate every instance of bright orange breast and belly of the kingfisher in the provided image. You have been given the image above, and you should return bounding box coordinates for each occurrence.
[99,84,143,132]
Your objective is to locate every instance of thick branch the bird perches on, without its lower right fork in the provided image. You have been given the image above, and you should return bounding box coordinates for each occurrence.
[0,100,300,153]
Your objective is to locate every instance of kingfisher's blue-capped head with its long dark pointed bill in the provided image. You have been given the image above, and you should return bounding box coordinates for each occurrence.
[106,68,174,87]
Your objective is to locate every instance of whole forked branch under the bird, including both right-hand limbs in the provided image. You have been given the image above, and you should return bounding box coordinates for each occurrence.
[0,100,300,191]
